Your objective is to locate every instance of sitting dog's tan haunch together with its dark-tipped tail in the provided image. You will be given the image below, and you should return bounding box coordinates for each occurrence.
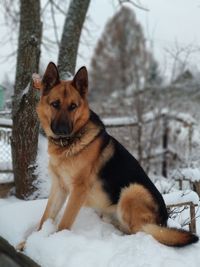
[117,184,198,246]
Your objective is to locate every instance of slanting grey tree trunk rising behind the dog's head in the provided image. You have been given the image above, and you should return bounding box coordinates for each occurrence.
[58,0,90,79]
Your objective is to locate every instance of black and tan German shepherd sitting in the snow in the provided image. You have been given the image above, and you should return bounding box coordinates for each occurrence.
[33,62,198,247]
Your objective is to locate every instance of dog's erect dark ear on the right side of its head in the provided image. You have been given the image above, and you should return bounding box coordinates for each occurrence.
[72,67,88,97]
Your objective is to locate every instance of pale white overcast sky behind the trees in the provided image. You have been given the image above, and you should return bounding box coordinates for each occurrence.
[0,0,200,83]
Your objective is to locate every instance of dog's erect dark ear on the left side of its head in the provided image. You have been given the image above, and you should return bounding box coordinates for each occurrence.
[42,62,60,94]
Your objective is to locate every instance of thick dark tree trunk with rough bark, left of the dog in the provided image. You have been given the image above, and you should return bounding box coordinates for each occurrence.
[12,0,42,199]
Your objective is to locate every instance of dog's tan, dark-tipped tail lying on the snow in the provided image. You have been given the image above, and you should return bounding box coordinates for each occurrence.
[142,224,199,247]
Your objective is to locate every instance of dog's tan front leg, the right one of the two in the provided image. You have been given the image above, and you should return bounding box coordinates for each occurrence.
[58,186,87,231]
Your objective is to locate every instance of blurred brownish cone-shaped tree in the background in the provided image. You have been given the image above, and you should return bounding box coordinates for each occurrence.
[90,6,151,102]
